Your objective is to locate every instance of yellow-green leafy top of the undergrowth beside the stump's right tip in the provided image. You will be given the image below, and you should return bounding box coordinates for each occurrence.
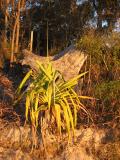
[76,31,120,70]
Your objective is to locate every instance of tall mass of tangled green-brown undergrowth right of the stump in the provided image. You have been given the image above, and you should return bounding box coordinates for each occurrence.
[76,30,120,123]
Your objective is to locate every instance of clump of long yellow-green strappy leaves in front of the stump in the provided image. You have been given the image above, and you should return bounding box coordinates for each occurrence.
[17,61,92,142]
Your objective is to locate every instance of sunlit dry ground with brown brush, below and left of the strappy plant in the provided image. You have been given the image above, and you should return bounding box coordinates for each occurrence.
[0,70,120,160]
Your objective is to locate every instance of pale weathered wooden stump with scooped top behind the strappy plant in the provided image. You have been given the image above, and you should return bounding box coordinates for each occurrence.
[21,45,87,80]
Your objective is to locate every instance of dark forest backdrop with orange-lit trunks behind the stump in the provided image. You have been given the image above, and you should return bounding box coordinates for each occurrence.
[0,0,120,59]
